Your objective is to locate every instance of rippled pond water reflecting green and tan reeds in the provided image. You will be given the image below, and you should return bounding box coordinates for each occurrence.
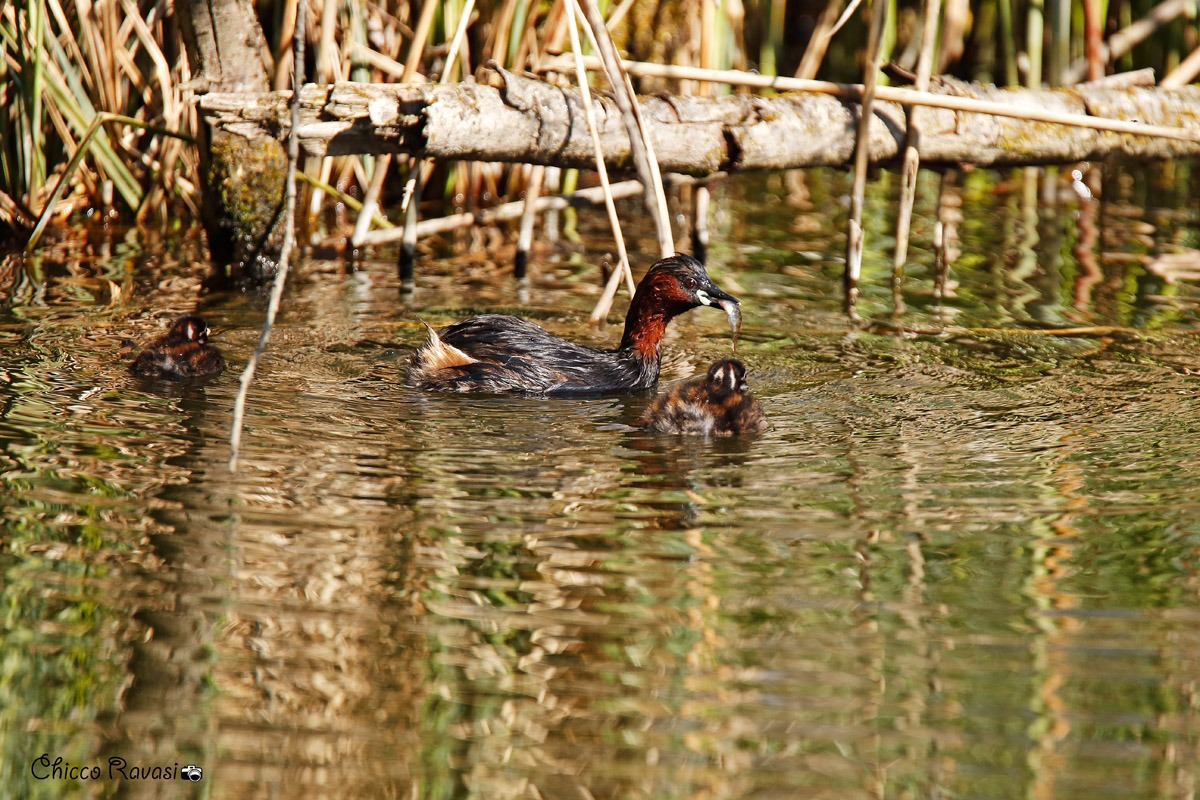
[0,165,1200,799]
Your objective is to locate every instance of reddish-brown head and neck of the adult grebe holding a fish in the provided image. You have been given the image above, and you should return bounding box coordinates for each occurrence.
[619,254,738,361]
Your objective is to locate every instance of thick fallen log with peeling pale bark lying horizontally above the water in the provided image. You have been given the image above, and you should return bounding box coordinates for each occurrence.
[200,73,1200,181]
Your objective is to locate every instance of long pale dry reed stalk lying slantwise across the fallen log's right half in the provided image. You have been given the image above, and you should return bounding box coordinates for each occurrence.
[542,59,1200,142]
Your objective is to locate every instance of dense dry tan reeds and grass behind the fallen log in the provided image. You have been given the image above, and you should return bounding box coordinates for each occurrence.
[0,0,1200,247]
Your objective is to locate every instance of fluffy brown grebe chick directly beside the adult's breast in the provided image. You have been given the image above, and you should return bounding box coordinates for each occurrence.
[641,359,767,437]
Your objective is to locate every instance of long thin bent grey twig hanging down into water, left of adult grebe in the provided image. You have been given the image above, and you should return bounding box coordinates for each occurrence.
[229,0,308,473]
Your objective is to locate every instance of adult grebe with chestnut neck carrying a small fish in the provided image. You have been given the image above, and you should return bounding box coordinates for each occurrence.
[407,254,738,395]
